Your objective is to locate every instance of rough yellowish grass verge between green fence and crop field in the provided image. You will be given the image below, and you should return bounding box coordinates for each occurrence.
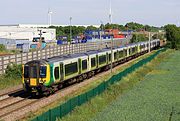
[58,51,174,121]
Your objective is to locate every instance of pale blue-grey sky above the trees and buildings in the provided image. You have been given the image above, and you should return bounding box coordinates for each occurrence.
[0,0,180,26]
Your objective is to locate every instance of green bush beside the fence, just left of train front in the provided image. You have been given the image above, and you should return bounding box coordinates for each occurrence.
[5,63,22,78]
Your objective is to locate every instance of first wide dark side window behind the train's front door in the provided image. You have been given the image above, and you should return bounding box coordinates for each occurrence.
[65,62,78,76]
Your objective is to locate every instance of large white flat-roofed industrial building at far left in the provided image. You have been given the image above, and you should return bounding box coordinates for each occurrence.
[0,24,56,41]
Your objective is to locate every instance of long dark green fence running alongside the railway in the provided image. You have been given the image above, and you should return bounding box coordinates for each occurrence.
[33,49,165,121]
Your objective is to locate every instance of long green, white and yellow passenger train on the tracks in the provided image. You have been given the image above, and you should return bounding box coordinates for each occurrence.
[22,40,160,94]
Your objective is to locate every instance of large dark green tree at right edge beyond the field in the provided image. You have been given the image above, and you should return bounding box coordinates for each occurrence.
[165,25,180,49]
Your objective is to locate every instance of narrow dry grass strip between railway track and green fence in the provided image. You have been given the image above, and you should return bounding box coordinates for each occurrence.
[24,51,155,120]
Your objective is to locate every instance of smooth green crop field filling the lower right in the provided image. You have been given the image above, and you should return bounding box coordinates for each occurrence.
[91,51,180,121]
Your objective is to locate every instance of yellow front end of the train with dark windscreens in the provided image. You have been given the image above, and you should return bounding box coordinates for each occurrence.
[22,60,50,93]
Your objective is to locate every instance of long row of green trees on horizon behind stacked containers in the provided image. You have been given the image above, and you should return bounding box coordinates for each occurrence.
[49,22,163,39]
